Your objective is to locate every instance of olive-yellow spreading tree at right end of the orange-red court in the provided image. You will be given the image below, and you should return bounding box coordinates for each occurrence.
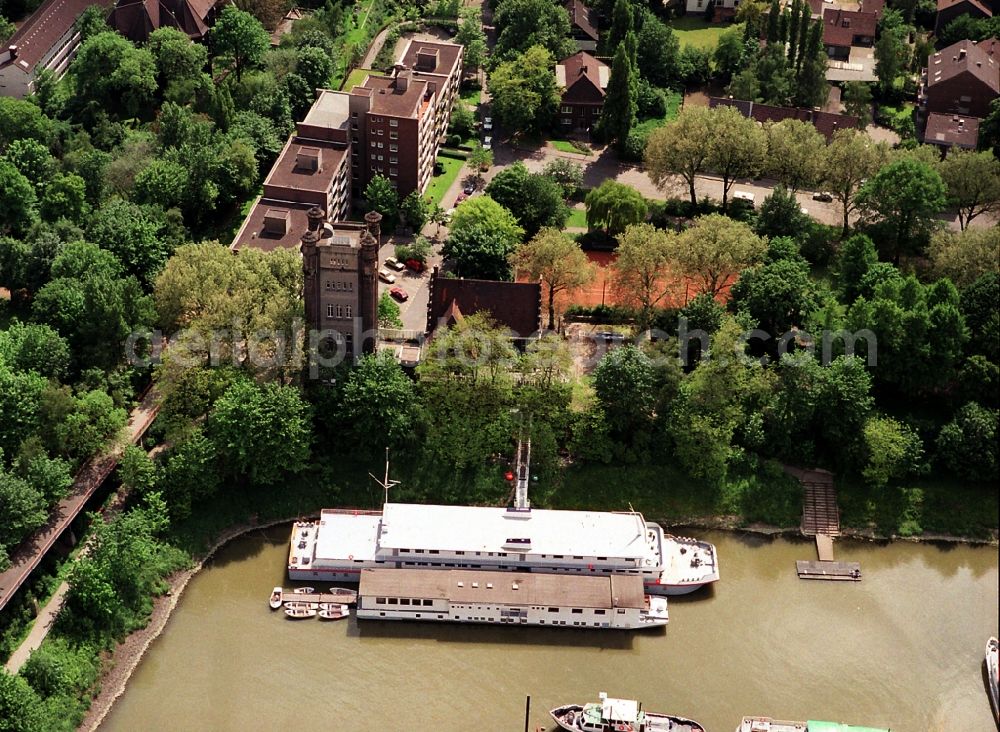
[670,214,767,297]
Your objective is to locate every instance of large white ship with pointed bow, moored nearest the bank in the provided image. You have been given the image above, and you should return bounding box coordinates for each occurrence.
[288,503,719,595]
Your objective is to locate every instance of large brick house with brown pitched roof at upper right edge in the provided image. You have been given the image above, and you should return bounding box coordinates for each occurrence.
[918,39,1000,118]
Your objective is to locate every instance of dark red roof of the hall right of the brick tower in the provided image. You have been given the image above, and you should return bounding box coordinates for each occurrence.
[427,269,542,338]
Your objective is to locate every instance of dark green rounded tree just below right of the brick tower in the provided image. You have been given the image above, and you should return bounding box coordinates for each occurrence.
[343,354,416,454]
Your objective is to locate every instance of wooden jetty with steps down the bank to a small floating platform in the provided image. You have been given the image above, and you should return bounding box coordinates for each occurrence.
[785,467,861,582]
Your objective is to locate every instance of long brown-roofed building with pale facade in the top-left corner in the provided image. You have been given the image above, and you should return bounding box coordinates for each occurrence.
[0,0,113,98]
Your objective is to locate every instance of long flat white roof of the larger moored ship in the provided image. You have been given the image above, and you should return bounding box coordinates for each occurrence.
[379,503,649,558]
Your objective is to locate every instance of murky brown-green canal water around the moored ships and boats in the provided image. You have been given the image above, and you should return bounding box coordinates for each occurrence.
[101,528,998,732]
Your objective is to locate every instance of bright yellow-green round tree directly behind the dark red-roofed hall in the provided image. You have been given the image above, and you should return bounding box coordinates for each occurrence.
[441,196,524,280]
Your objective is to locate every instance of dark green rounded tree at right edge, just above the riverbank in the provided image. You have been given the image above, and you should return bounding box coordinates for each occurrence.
[937,402,1000,481]
